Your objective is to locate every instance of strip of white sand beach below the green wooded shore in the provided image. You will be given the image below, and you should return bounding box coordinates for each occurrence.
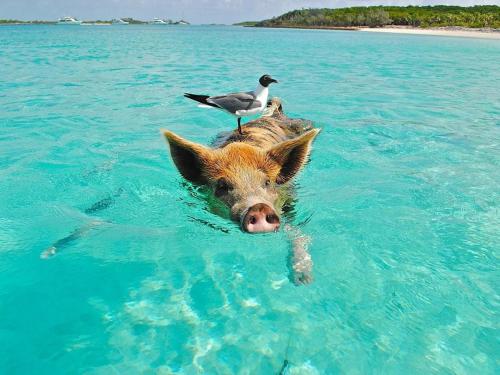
[358,27,500,39]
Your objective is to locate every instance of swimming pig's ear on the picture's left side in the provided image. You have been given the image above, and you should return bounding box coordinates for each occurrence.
[162,130,210,185]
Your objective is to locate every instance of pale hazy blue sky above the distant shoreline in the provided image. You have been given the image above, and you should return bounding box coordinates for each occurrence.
[0,0,500,24]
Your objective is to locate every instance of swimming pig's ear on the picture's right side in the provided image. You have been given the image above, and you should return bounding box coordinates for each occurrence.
[267,129,320,184]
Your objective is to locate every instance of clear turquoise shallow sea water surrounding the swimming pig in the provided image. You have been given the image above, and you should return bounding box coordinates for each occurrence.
[0,26,500,374]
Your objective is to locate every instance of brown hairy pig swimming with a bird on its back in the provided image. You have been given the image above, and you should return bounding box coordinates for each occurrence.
[162,98,320,283]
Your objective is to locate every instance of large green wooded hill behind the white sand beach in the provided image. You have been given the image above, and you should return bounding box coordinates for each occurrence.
[253,5,500,29]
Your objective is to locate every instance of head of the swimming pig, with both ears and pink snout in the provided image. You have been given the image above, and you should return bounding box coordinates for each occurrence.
[163,129,319,233]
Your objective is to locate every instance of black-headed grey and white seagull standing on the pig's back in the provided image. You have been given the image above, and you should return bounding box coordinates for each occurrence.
[184,74,278,134]
